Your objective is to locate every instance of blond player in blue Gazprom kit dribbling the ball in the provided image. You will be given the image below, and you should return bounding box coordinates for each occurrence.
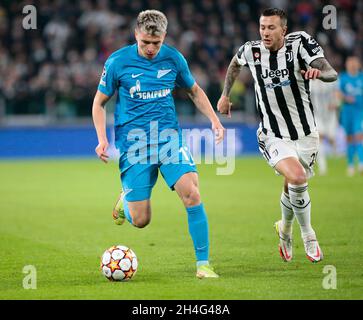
[92,10,224,278]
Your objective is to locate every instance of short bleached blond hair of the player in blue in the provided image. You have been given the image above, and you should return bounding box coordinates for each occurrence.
[136,10,168,36]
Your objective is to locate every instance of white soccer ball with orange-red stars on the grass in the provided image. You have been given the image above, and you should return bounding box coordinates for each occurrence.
[101,245,138,281]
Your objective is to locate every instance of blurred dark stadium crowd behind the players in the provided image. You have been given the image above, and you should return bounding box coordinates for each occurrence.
[0,0,363,122]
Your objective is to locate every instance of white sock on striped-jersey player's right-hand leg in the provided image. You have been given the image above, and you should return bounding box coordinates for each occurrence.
[288,183,315,238]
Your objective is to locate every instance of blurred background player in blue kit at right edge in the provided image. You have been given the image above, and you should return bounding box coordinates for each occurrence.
[338,56,363,176]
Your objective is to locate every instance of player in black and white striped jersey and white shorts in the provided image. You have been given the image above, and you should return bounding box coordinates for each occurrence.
[217,8,337,262]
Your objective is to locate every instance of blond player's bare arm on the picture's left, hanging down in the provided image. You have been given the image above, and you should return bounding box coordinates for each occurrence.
[92,90,110,163]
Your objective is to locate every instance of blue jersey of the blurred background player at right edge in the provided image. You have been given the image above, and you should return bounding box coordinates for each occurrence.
[339,72,363,112]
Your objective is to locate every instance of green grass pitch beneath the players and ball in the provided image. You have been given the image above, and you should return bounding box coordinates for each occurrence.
[0,157,363,300]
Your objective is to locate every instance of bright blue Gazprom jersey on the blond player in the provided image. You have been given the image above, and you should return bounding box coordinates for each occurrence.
[98,43,195,151]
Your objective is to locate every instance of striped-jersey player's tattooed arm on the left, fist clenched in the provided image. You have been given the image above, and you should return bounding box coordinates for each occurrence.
[217,56,241,118]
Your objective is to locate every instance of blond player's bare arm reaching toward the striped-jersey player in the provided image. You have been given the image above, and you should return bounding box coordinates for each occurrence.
[188,83,225,143]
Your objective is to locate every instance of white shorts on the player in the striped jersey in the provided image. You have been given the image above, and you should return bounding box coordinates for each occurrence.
[257,128,319,178]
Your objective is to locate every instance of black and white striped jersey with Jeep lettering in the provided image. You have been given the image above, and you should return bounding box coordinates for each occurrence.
[237,31,324,140]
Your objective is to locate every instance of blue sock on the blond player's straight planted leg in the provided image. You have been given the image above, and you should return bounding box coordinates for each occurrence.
[186,203,209,266]
